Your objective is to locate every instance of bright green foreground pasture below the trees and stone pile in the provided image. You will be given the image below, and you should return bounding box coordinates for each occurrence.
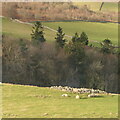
[0,84,118,118]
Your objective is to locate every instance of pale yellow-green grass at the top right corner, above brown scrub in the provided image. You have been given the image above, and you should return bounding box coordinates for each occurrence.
[74,2,118,12]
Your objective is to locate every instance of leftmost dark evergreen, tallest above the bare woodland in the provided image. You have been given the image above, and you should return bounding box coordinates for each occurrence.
[31,22,46,43]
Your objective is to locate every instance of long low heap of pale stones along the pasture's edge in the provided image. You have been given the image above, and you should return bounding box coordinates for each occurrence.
[50,86,106,94]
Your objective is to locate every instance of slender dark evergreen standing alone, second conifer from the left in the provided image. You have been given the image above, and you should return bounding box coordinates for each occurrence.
[55,27,66,48]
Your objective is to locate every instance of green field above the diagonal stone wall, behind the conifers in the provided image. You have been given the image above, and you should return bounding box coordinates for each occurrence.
[43,21,118,44]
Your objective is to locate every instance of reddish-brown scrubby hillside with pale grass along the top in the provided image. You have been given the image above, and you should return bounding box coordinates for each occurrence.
[2,2,118,21]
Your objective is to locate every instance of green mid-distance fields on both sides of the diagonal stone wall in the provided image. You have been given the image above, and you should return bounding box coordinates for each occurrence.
[2,18,118,45]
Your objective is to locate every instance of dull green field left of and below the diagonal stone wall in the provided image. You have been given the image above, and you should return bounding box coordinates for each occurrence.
[2,18,55,41]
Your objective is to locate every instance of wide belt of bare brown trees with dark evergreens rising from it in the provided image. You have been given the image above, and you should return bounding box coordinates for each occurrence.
[3,22,118,92]
